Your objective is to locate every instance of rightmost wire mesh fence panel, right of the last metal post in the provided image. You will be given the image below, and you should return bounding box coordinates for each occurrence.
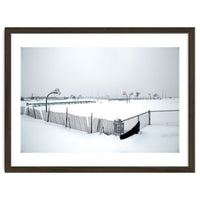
[151,110,179,126]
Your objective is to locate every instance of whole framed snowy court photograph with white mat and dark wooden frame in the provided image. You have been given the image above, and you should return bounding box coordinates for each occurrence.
[5,27,195,173]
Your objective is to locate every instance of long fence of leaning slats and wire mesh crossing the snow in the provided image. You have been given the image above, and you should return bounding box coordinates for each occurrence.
[21,106,179,135]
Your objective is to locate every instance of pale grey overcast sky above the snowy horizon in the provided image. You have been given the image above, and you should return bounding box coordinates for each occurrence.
[21,47,179,97]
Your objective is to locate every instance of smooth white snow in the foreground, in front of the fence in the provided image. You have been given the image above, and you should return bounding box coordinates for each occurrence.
[21,115,179,153]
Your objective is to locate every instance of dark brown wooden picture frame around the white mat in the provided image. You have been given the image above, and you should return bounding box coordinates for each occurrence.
[5,27,195,173]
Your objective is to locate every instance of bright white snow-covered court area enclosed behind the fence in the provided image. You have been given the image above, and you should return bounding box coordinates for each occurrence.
[22,98,179,120]
